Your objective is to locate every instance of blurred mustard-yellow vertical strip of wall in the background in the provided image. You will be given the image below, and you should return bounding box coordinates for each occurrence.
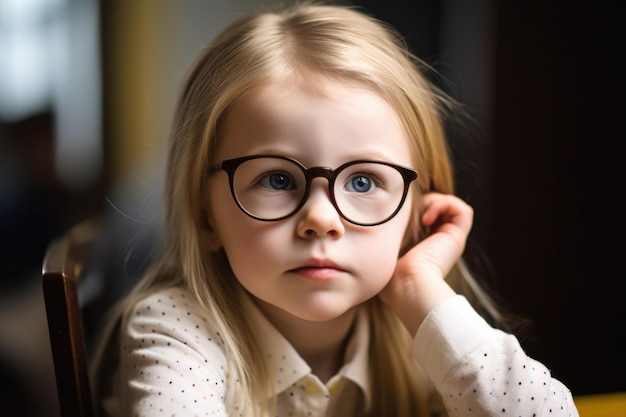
[103,0,176,186]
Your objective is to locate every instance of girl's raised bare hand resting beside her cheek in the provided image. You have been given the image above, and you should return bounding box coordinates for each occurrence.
[380,193,474,336]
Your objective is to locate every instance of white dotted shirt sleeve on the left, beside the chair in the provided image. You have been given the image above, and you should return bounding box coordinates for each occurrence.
[114,290,227,417]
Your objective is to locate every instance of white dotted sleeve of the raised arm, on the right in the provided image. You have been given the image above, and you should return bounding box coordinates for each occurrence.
[413,295,578,417]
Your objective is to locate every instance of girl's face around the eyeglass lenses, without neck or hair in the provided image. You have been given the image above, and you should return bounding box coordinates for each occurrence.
[205,83,413,321]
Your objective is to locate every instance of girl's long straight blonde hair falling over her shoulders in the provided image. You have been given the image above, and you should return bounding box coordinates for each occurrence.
[95,4,497,417]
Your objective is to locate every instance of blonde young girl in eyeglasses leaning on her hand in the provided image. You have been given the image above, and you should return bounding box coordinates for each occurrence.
[90,5,578,417]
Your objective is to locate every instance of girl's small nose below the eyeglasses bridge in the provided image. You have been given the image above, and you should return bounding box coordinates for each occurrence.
[297,178,345,239]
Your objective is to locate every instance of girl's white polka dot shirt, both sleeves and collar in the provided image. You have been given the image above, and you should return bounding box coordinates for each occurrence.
[102,289,578,417]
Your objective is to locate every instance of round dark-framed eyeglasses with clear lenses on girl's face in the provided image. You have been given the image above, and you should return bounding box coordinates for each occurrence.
[211,155,417,226]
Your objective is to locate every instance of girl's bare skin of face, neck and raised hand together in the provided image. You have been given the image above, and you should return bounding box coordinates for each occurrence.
[204,79,471,379]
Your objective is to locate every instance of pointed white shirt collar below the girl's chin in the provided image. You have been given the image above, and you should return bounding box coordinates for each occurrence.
[244,297,371,404]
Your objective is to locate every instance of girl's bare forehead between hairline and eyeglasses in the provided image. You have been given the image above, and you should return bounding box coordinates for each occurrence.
[215,80,409,165]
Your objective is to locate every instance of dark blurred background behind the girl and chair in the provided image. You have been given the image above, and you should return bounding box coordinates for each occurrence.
[0,0,626,416]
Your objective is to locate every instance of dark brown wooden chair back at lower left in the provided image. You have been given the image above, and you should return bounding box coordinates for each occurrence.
[42,221,98,417]
